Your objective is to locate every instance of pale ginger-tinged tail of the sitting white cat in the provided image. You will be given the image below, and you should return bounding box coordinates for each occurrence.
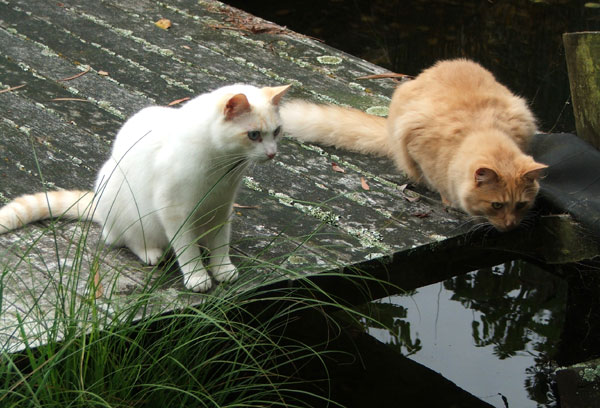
[0,190,94,234]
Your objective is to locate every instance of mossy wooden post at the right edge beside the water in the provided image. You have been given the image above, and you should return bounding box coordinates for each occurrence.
[563,31,600,149]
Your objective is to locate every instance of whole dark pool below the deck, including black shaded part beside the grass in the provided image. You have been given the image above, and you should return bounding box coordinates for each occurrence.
[279,262,567,408]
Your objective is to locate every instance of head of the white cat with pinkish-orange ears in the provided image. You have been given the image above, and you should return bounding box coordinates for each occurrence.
[223,86,289,162]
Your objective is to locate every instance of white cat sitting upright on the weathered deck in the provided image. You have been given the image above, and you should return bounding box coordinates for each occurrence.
[0,85,289,292]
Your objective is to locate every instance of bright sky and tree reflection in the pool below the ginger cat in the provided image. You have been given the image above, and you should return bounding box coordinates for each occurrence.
[360,262,566,407]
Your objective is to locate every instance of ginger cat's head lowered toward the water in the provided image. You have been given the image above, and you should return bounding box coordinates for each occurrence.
[465,160,546,231]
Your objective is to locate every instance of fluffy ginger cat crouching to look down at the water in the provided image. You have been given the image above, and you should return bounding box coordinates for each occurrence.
[281,59,547,231]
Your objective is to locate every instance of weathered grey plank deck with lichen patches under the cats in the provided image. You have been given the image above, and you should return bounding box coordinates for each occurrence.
[0,0,592,351]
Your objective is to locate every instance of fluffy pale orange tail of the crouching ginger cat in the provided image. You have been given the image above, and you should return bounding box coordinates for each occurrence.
[279,99,391,156]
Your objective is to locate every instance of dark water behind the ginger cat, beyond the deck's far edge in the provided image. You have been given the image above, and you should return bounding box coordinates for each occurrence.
[226,0,600,131]
